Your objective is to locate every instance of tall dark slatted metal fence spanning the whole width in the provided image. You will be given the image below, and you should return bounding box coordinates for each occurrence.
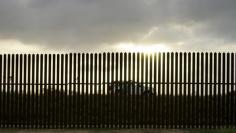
[0,52,236,128]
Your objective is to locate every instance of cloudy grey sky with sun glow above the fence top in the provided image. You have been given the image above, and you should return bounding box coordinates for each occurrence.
[0,0,236,53]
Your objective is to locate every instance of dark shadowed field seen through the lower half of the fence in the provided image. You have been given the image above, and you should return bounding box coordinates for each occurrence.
[0,92,235,128]
